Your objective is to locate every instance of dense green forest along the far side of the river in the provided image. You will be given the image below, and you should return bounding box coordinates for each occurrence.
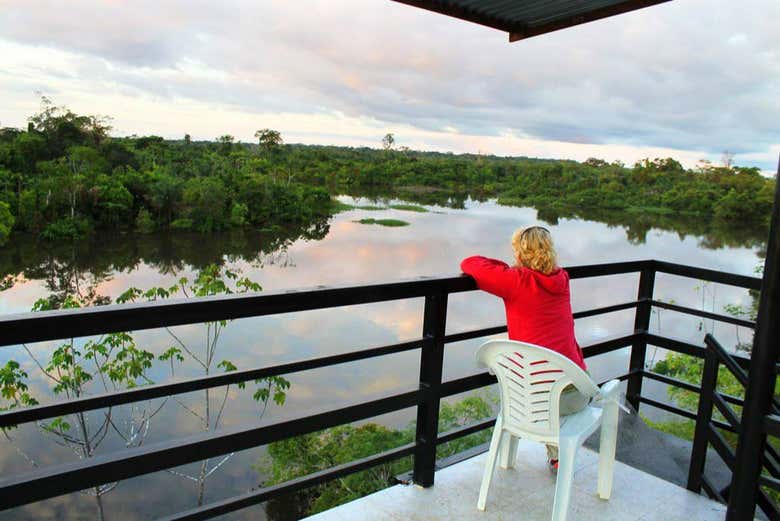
[0,98,774,246]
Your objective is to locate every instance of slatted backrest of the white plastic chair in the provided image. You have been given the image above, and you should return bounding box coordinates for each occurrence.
[477,340,599,441]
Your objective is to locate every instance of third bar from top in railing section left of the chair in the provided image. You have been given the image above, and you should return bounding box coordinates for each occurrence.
[0,390,420,509]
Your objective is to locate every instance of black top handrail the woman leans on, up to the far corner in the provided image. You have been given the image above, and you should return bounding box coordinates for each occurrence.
[0,261,652,346]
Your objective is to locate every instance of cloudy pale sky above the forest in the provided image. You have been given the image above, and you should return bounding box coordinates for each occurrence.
[0,0,780,173]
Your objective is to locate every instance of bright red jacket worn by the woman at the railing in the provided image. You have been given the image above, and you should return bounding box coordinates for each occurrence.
[460,256,587,369]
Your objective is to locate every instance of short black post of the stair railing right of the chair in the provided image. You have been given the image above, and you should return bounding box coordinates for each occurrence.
[688,346,718,493]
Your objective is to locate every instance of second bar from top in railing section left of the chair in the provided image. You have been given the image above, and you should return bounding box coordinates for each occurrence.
[0,339,430,428]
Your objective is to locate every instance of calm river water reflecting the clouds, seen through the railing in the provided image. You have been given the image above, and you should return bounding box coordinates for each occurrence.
[0,197,762,520]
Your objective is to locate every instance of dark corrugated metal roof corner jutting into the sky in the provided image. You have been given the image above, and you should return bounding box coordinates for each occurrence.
[394,0,670,42]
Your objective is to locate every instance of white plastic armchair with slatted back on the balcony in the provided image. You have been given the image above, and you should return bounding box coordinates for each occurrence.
[477,340,619,521]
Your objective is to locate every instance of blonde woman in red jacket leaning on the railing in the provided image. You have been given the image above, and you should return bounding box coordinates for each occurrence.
[460,226,588,472]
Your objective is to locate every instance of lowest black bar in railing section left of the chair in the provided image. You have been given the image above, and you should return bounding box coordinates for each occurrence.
[158,443,414,521]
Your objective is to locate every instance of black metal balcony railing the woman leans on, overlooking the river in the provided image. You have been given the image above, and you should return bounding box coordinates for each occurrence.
[0,260,768,520]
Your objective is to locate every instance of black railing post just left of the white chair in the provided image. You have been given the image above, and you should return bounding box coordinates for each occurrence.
[414,293,447,487]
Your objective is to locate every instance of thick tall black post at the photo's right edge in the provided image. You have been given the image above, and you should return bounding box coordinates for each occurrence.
[726,156,780,521]
